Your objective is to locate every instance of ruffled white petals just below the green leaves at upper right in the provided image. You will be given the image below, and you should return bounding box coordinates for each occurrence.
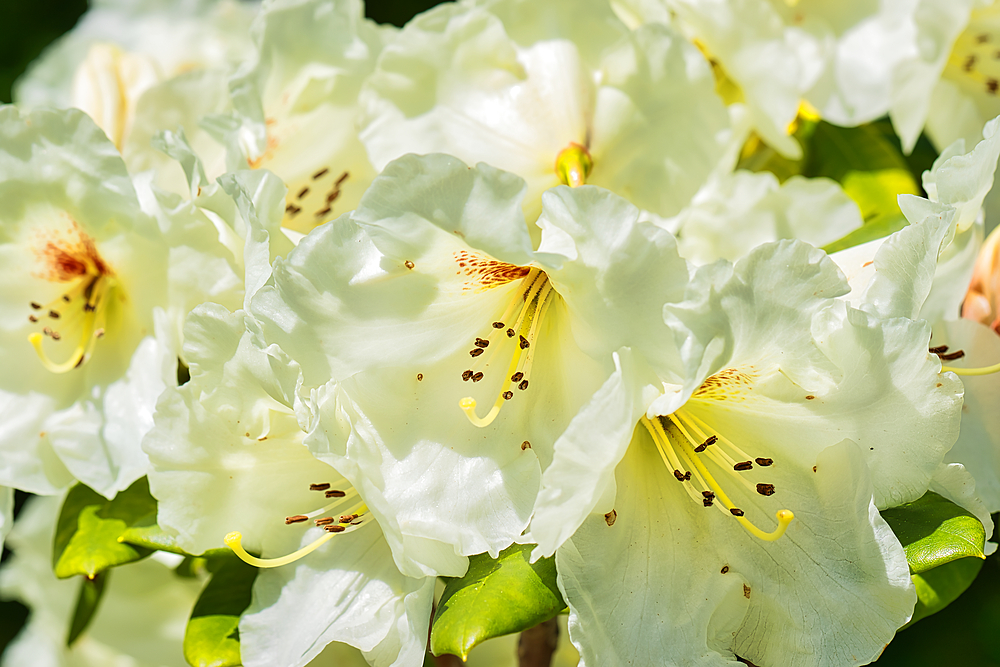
[663,171,863,264]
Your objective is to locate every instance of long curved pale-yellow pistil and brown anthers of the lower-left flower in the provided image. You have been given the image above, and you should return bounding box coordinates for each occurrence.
[223,480,372,568]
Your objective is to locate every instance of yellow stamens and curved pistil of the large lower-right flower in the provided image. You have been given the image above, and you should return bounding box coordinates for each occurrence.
[640,409,795,542]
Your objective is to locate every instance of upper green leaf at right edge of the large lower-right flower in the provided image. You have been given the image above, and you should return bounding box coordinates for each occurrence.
[882,492,986,574]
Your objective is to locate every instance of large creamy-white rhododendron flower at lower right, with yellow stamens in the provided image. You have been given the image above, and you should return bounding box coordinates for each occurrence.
[530,241,961,665]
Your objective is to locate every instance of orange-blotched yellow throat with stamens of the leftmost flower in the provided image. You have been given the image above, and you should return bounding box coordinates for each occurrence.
[28,224,120,373]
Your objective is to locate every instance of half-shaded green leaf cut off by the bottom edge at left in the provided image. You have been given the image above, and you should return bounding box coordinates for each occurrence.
[184,554,257,667]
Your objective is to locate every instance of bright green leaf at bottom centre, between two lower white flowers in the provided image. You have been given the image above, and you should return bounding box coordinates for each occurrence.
[431,544,566,660]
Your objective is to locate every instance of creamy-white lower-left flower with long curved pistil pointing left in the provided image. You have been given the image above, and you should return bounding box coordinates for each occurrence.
[144,305,434,667]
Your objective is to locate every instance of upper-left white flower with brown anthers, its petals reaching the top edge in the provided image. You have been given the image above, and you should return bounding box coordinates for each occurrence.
[212,0,393,233]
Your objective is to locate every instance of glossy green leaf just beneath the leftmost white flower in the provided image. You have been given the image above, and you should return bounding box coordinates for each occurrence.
[52,477,156,579]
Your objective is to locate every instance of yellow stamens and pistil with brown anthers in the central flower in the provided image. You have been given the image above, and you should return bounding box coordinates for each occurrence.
[458,268,555,428]
